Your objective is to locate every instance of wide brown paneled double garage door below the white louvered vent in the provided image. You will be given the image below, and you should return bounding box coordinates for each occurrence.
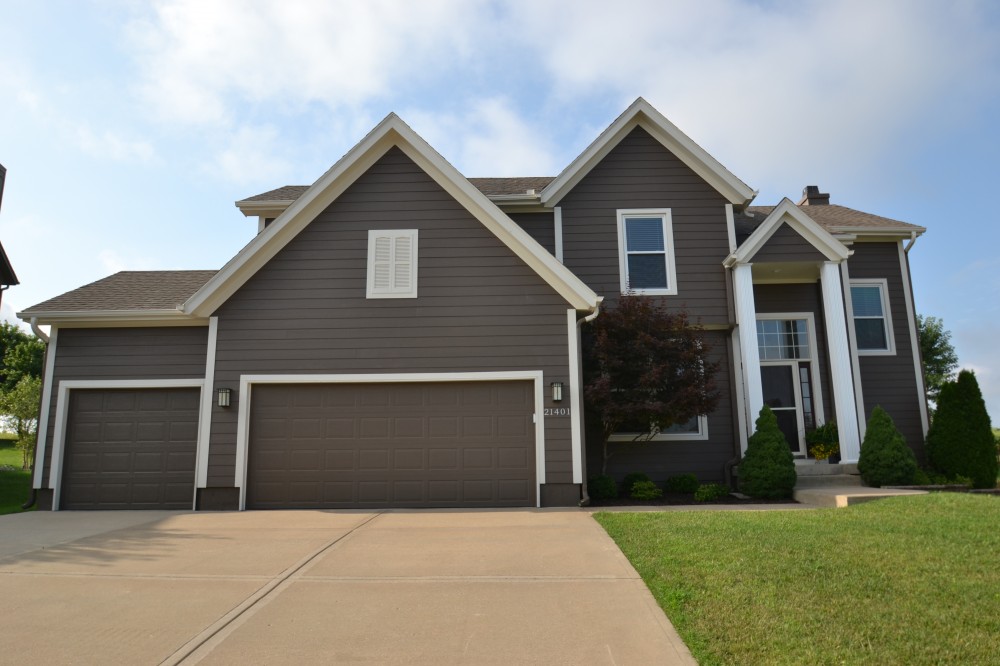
[246,381,535,509]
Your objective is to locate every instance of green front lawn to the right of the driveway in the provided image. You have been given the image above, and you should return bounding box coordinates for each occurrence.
[595,493,1000,665]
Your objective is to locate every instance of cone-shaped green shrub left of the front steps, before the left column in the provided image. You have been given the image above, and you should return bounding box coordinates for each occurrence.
[739,405,796,499]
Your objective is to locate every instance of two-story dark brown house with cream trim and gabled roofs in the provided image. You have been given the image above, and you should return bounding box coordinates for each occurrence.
[19,99,927,509]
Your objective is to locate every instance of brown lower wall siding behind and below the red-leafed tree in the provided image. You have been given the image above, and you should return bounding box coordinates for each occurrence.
[587,332,736,485]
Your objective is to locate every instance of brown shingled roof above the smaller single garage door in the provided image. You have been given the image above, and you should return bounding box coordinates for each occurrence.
[18,271,218,319]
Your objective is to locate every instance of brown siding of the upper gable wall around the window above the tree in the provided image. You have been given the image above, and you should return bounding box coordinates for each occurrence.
[557,128,730,324]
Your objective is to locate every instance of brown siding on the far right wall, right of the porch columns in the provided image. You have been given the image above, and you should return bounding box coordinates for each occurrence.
[848,243,924,456]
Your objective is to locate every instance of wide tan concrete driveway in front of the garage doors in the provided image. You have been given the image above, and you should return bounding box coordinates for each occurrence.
[0,510,694,664]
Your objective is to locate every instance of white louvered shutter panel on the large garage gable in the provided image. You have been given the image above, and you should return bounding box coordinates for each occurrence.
[367,229,417,298]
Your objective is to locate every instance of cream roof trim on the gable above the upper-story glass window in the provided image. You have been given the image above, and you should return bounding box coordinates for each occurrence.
[541,97,757,206]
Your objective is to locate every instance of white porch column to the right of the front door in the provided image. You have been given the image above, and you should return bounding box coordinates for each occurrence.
[820,261,861,463]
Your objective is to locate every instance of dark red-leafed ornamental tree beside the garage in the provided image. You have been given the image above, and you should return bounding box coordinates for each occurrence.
[583,294,719,474]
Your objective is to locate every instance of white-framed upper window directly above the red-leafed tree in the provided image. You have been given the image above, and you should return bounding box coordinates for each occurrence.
[618,209,677,296]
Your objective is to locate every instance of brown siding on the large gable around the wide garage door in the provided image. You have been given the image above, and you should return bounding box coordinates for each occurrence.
[208,148,572,487]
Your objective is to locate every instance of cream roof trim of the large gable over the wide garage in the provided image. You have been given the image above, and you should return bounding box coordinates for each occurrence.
[183,113,600,317]
